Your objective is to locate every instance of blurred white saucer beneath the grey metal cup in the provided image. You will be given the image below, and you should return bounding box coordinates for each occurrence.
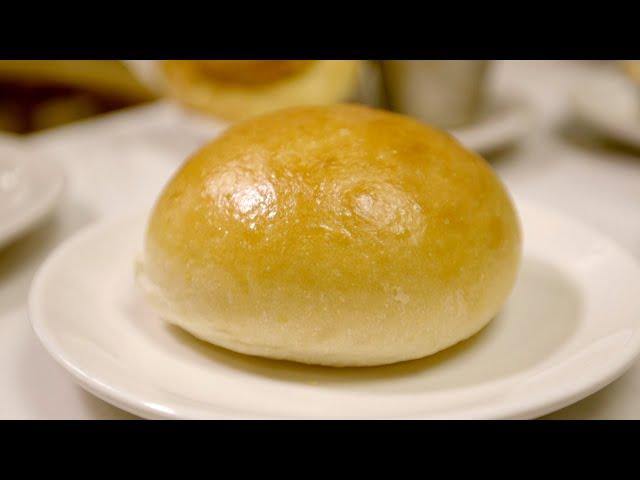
[449,93,534,154]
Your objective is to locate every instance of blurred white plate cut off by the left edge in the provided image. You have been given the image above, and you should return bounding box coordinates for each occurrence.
[0,143,64,248]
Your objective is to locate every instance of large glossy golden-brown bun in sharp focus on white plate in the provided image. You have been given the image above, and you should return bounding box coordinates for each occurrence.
[138,105,521,366]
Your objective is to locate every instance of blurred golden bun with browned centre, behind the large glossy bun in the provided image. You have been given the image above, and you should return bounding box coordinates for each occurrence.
[128,60,362,121]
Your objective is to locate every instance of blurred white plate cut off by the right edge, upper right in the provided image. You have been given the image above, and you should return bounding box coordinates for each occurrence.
[572,70,640,148]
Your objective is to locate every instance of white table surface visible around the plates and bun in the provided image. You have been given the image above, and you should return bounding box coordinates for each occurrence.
[0,61,640,419]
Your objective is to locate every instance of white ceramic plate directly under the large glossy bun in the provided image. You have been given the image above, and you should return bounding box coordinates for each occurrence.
[29,202,640,418]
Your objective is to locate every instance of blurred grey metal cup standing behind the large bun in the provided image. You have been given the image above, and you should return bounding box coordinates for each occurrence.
[382,60,489,128]
